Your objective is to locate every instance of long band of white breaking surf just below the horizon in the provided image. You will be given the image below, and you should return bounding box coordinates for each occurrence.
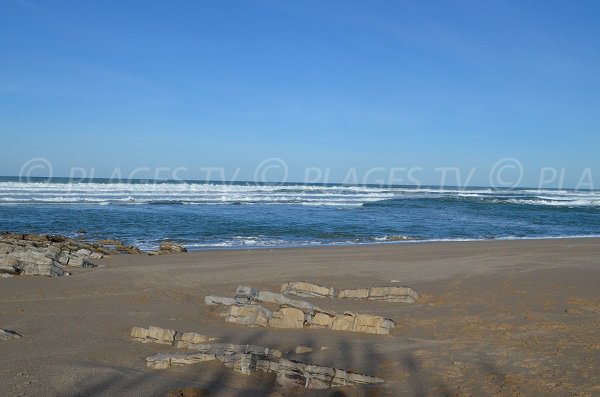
[0,182,600,207]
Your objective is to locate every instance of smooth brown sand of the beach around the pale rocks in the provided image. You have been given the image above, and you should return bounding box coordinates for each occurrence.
[0,239,600,397]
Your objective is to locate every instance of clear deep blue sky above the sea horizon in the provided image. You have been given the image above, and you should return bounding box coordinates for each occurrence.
[0,0,600,188]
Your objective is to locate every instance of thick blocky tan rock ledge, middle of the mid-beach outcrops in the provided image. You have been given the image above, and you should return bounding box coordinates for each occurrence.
[204,286,395,335]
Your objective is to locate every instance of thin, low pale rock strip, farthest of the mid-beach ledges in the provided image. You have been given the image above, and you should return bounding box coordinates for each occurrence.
[281,281,419,303]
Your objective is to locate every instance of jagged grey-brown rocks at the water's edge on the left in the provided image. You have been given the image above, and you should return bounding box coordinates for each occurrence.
[0,233,141,276]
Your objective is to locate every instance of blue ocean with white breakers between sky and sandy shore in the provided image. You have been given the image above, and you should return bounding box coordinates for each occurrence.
[0,177,600,249]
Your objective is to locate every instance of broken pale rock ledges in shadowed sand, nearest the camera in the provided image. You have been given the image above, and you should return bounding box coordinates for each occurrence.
[131,327,383,389]
